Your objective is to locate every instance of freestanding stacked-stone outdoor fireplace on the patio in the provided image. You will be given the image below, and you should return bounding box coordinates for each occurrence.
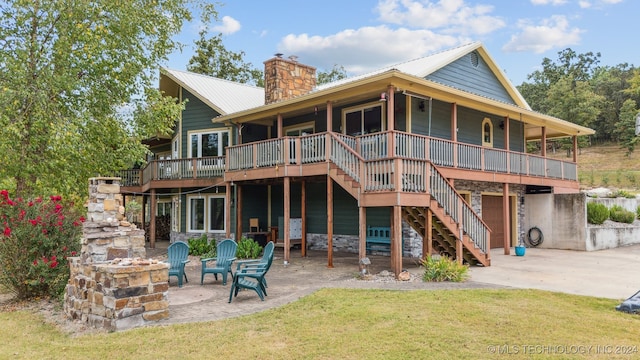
[64,177,169,331]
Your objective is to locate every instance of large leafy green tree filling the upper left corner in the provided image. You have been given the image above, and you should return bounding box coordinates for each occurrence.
[0,0,217,197]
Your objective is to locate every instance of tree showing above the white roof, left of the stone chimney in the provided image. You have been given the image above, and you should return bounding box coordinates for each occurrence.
[187,30,264,86]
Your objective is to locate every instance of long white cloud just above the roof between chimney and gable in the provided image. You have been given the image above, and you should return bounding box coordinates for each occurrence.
[278,25,462,75]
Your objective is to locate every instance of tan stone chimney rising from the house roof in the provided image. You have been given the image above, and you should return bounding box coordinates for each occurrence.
[264,54,316,105]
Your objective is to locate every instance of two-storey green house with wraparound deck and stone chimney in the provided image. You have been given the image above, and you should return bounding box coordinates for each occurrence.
[122,42,594,275]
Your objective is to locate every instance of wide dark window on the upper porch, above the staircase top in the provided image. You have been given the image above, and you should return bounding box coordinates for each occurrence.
[342,103,384,136]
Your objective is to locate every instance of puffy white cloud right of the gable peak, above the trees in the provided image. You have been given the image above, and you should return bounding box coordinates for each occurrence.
[502,15,584,54]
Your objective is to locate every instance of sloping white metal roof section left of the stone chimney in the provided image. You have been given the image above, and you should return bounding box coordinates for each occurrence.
[161,68,264,115]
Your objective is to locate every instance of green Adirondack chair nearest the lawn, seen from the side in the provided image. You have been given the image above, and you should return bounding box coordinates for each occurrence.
[229,242,273,302]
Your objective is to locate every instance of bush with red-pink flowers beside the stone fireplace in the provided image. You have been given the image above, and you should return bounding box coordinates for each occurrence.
[0,190,84,299]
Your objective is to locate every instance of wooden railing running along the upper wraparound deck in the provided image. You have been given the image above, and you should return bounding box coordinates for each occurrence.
[117,131,577,191]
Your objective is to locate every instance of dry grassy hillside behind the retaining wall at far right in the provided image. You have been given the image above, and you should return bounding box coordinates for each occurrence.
[549,144,640,193]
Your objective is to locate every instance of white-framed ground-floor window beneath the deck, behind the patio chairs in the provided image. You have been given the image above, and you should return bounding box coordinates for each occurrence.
[187,194,226,233]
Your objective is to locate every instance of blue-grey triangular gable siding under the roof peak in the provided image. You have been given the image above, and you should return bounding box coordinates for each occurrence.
[426,52,515,105]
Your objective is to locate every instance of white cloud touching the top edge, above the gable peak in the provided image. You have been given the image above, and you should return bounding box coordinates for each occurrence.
[376,0,505,36]
